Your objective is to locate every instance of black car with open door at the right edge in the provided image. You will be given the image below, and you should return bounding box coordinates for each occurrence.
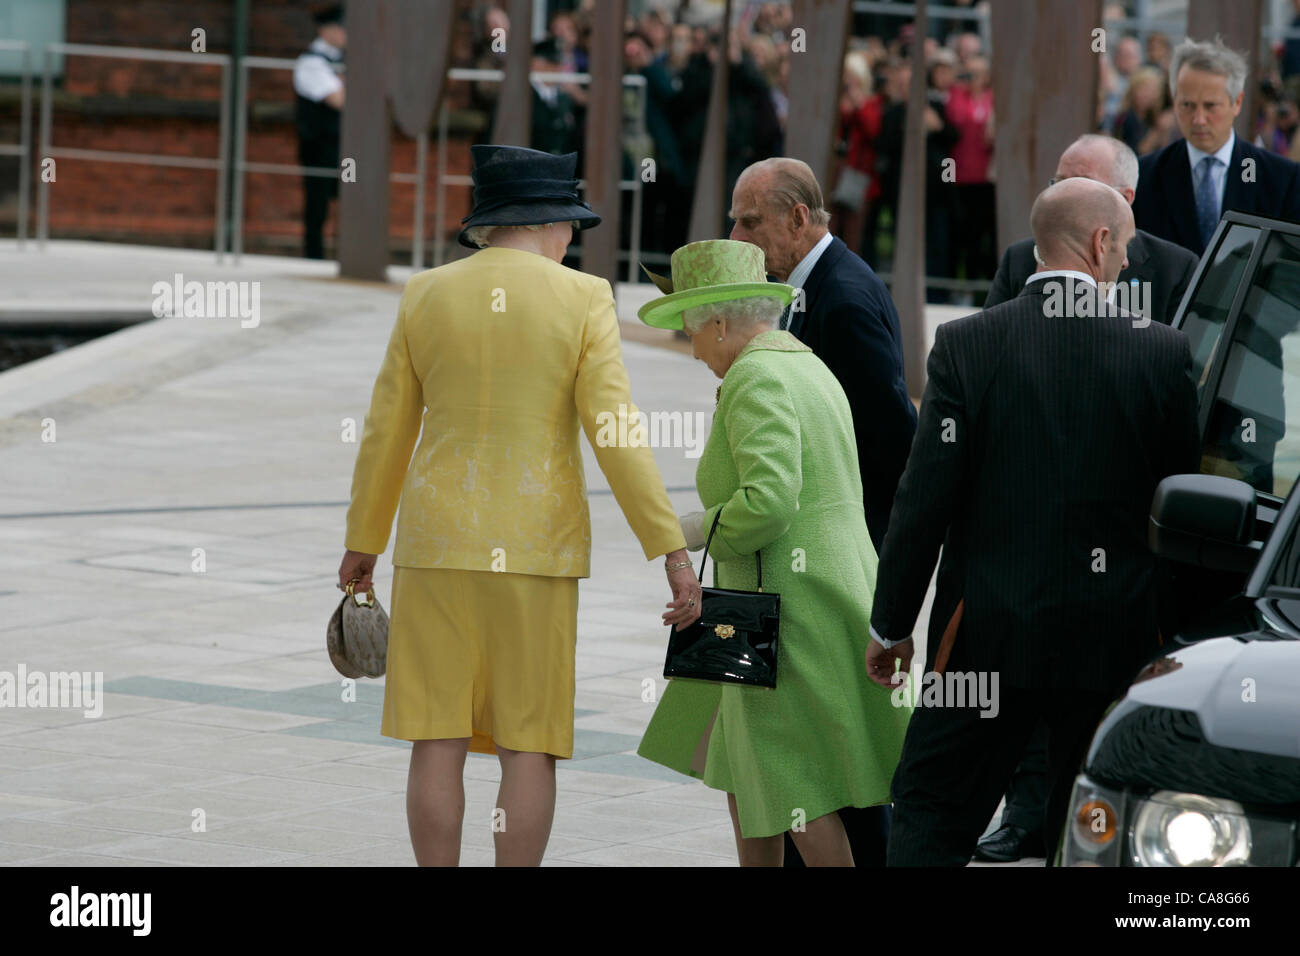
[1060,212,1300,866]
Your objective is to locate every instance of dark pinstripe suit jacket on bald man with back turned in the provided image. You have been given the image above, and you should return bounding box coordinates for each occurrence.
[872,280,1199,692]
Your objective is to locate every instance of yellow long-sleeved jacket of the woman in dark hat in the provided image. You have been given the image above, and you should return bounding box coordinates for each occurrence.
[345,247,685,578]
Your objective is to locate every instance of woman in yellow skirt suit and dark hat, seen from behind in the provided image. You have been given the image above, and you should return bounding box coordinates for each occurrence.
[339,146,699,865]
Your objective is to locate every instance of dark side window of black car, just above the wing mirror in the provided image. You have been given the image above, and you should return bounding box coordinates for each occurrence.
[1201,233,1300,498]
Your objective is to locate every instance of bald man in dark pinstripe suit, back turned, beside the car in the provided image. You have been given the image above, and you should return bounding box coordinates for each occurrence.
[866,178,1199,866]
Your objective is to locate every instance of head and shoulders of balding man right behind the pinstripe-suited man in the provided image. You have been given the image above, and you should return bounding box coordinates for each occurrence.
[984,133,1197,325]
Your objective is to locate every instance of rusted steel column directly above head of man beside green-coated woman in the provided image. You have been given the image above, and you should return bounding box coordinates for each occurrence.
[785,0,853,193]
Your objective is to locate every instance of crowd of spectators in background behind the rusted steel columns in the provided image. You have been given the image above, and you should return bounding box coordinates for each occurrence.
[452,0,1300,304]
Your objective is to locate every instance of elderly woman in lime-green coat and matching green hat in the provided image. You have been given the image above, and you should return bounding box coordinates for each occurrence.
[638,239,910,866]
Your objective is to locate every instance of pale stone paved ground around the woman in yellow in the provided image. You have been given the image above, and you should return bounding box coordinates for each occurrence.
[0,242,1013,866]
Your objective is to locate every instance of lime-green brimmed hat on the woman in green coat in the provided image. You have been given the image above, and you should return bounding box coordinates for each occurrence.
[637,239,794,329]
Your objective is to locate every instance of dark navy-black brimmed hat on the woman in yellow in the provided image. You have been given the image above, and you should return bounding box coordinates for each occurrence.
[458,144,601,248]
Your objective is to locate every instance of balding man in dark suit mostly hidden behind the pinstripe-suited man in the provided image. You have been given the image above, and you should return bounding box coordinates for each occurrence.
[975,133,1197,862]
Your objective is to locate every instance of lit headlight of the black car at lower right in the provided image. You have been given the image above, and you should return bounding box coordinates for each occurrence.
[1132,790,1251,866]
